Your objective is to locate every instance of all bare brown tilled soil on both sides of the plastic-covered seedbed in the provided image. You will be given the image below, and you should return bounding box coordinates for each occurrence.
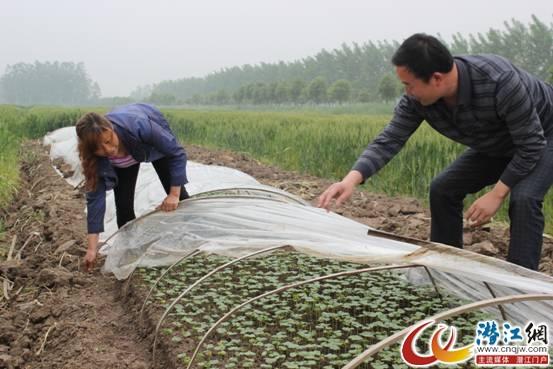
[0,142,553,369]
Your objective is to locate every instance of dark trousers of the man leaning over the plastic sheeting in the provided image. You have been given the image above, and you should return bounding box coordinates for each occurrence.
[430,137,553,270]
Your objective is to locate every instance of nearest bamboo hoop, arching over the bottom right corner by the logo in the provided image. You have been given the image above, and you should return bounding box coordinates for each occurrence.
[342,294,553,369]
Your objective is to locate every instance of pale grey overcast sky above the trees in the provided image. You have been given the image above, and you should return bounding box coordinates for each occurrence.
[0,0,553,96]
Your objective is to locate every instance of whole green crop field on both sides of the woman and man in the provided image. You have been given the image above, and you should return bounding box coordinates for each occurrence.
[0,106,553,233]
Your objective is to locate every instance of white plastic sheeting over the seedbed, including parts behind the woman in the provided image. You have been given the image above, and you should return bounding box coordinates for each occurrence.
[45,128,553,322]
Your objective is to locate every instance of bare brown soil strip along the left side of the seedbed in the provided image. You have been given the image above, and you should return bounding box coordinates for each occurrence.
[0,143,150,369]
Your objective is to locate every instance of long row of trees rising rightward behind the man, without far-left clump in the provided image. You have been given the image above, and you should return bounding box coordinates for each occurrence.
[134,16,553,104]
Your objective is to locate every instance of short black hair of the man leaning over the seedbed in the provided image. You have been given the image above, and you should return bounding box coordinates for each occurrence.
[392,33,453,82]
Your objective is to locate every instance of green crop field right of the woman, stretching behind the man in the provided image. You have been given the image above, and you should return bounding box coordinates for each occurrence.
[166,110,553,233]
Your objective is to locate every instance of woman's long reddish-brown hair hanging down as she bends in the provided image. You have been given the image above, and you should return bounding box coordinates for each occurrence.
[76,112,113,191]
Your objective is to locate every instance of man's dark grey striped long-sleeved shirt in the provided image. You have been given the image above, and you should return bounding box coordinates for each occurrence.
[353,55,553,188]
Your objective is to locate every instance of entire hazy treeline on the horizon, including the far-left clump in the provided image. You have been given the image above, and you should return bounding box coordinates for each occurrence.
[0,16,553,105]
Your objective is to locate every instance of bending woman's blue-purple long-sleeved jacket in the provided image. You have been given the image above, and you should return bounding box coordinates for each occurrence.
[86,104,188,234]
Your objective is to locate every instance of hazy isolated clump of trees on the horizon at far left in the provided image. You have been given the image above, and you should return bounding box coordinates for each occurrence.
[0,61,100,105]
